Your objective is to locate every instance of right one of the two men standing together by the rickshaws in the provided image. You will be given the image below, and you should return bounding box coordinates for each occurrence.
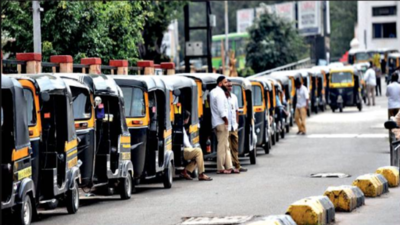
[226,80,247,172]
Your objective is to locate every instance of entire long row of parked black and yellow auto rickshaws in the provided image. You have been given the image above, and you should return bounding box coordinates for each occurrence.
[1,67,366,224]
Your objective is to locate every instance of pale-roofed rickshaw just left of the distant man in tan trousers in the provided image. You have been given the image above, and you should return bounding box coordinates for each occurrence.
[268,71,296,133]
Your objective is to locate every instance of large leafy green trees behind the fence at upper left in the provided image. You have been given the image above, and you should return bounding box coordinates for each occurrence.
[1,0,184,64]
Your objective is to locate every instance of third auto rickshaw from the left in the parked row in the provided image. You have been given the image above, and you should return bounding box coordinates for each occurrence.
[57,73,134,199]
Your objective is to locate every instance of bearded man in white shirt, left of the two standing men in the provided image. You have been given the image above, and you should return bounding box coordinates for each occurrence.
[210,76,239,174]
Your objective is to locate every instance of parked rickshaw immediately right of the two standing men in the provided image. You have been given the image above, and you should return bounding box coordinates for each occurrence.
[229,77,257,164]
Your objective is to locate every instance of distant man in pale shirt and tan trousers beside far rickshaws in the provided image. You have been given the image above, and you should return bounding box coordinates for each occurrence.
[295,79,310,135]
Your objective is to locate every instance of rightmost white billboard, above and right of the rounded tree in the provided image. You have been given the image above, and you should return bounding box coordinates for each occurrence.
[297,1,321,36]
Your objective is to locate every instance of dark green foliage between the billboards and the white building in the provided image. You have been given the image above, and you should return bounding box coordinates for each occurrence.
[330,1,357,58]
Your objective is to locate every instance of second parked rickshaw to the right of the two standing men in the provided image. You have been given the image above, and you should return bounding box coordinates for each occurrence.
[248,77,275,154]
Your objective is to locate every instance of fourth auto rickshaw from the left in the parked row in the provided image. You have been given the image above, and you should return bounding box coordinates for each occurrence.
[112,76,175,188]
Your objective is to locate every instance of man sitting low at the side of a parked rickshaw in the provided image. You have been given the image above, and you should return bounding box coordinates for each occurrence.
[181,111,212,181]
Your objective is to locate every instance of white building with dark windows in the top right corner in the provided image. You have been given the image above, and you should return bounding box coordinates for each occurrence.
[356,1,400,51]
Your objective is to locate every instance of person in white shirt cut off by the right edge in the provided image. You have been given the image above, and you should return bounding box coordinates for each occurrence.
[386,73,400,119]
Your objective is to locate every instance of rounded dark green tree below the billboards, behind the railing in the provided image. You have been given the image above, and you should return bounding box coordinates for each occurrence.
[246,13,309,73]
